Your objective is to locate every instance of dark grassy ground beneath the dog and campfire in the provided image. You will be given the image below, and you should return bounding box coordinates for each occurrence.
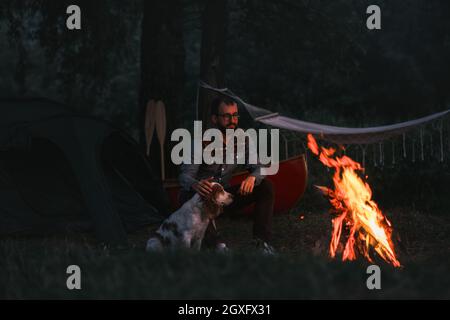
[0,202,450,299]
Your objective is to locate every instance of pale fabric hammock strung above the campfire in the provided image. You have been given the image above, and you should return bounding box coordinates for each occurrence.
[199,81,450,145]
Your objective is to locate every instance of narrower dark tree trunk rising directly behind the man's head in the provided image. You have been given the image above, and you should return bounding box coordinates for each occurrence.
[197,0,227,128]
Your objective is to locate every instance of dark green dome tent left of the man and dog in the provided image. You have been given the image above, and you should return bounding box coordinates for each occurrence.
[0,99,168,243]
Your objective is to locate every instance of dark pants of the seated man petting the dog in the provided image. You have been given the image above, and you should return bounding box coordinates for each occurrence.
[180,179,274,247]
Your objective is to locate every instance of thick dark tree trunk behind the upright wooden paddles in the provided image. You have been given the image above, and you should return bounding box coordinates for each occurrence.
[138,0,185,178]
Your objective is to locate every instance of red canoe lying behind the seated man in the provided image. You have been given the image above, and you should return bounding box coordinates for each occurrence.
[164,155,308,214]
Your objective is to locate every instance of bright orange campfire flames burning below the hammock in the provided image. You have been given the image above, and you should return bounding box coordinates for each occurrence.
[308,134,400,267]
